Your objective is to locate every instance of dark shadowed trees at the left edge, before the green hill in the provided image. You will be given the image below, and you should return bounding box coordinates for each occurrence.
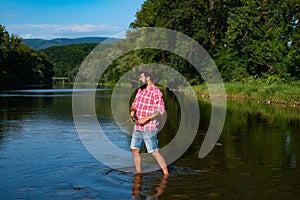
[0,25,53,89]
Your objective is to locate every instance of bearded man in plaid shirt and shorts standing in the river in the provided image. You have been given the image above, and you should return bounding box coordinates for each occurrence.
[130,71,169,174]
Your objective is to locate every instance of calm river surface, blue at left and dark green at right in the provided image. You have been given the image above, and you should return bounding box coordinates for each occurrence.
[0,88,300,199]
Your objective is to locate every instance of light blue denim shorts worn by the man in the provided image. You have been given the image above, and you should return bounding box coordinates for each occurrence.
[130,130,159,153]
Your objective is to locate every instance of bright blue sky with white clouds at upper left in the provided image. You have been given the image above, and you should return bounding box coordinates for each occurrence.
[0,0,145,39]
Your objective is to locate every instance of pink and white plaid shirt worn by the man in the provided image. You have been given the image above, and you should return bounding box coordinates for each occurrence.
[132,84,165,131]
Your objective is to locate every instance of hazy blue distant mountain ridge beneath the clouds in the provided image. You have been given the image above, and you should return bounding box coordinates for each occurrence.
[23,37,120,50]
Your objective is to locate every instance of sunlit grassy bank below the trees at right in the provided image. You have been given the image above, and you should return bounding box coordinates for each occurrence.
[193,81,300,107]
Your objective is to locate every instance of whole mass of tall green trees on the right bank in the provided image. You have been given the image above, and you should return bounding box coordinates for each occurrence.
[103,0,300,84]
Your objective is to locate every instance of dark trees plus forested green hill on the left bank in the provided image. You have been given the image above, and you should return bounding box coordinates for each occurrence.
[0,25,97,89]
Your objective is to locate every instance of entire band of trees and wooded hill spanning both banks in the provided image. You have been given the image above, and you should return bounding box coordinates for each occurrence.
[0,0,300,86]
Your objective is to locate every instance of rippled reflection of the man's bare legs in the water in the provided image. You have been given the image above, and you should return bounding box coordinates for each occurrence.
[131,173,169,200]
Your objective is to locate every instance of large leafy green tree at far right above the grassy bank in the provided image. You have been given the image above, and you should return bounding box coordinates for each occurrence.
[217,0,300,79]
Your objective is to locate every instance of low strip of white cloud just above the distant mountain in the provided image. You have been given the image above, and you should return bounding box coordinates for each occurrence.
[6,24,125,39]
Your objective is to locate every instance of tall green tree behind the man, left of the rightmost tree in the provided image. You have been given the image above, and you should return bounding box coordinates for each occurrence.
[130,0,241,84]
